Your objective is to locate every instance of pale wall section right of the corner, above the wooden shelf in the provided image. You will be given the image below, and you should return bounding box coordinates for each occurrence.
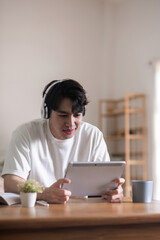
[110,0,160,178]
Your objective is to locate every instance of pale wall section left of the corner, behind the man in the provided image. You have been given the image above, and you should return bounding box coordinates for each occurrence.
[0,0,105,160]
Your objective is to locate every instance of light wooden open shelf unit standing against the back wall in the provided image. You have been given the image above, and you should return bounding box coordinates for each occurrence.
[99,94,147,197]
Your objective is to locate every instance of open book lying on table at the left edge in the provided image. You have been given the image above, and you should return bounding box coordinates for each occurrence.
[0,192,21,205]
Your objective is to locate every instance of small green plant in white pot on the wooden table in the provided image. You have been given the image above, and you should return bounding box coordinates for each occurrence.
[18,180,43,207]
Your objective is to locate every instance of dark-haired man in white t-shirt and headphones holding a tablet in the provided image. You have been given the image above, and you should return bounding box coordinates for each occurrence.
[2,79,124,203]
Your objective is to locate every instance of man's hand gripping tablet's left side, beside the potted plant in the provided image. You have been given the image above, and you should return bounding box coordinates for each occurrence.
[37,178,71,203]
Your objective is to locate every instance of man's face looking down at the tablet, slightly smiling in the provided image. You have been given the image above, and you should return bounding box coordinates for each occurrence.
[49,98,82,140]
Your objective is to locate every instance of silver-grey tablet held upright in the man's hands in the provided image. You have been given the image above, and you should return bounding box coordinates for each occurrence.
[63,161,125,197]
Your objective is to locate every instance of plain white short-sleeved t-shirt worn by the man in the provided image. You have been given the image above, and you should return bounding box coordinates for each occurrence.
[2,119,110,187]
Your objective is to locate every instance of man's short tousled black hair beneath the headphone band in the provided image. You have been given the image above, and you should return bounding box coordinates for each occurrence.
[43,79,88,118]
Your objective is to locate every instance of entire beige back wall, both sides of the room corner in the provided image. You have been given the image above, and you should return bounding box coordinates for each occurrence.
[0,0,160,180]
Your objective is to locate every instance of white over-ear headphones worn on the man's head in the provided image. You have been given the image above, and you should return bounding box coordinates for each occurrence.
[41,80,62,119]
